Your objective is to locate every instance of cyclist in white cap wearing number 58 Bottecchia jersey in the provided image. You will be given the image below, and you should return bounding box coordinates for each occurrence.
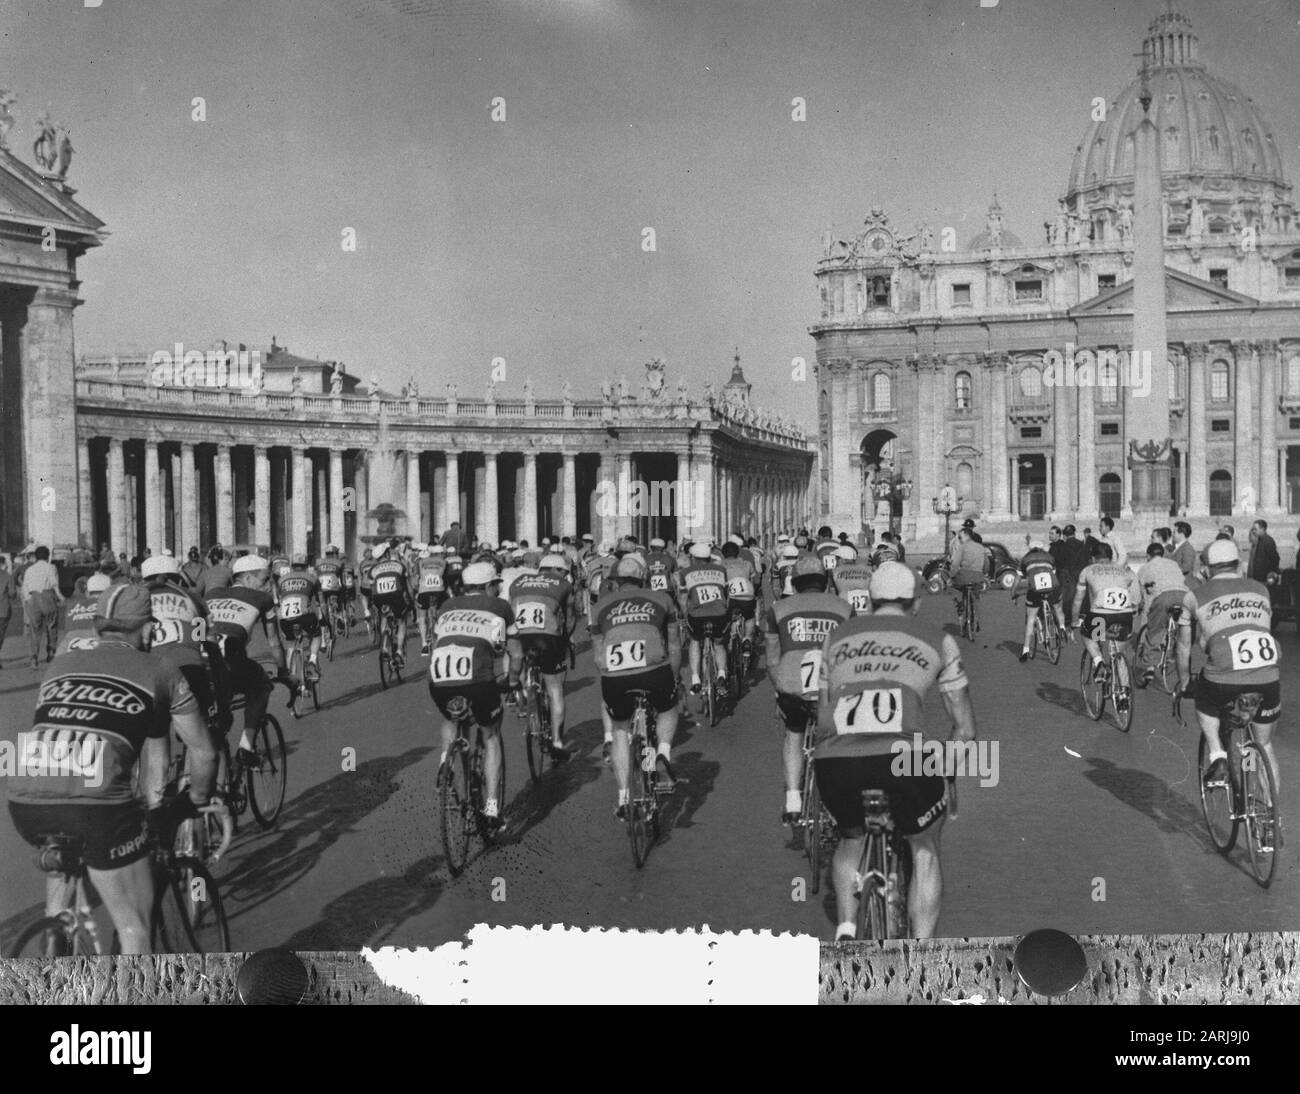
[1178,539,1282,789]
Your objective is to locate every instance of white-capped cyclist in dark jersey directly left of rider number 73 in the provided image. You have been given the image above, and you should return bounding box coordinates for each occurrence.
[205,555,293,764]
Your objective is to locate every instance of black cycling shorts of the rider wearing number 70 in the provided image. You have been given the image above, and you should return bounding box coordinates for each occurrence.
[814,752,948,838]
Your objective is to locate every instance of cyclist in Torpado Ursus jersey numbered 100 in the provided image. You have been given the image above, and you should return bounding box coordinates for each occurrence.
[8,583,217,954]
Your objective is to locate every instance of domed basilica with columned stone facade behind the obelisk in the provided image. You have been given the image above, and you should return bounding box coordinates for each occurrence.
[810,5,1300,538]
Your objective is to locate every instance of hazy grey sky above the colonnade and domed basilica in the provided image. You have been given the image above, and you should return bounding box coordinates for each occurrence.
[0,0,1300,427]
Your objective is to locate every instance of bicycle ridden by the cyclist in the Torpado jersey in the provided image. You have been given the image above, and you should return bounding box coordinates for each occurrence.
[10,810,230,958]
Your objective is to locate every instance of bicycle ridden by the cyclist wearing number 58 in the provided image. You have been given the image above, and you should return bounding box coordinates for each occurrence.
[1174,691,1282,889]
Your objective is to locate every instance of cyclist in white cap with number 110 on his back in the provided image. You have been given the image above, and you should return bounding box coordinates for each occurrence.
[429,563,514,828]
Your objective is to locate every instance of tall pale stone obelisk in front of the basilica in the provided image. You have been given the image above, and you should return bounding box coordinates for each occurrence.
[1121,57,1173,524]
